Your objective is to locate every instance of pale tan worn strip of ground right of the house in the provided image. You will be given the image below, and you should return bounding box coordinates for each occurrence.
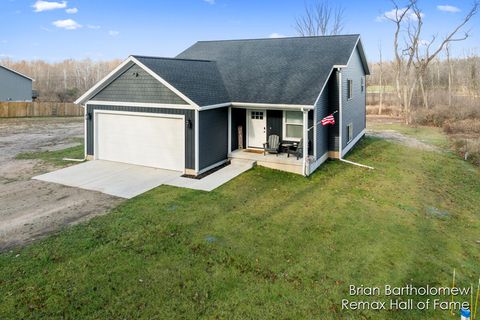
[368,122,450,148]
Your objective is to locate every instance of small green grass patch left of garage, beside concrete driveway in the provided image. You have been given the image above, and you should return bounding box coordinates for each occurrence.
[15,139,85,166]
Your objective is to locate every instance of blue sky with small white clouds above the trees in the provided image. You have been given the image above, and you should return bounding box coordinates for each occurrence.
[0,0,480,62]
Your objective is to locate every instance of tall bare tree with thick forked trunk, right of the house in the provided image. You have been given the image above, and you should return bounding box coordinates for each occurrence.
[385,0,480,123]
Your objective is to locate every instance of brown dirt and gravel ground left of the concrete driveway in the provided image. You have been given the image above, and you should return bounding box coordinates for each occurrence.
[0,118,122,251]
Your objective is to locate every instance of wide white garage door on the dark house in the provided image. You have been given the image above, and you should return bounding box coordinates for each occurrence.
[95,112,185,171]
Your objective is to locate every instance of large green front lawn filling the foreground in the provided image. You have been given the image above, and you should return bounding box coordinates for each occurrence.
[0,138,480,319]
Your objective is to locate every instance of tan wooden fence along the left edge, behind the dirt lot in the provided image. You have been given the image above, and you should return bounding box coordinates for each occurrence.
[0,102,83,118]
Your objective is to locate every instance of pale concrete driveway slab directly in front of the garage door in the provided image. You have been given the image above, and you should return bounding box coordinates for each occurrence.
[33,160,182,199]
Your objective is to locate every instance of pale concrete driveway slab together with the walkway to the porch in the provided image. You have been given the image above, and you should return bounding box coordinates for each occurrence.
[32,160,255,199]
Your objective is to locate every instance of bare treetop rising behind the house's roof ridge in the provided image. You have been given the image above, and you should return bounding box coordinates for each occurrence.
[295,0,345,37]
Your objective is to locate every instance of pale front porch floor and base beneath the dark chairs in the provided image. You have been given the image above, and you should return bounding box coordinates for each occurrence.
[228,149,304,174]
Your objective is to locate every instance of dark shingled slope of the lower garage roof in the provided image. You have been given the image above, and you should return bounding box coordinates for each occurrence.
[133,56,230,106]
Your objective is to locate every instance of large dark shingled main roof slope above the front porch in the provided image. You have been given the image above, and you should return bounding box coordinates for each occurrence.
[178,35,368,105]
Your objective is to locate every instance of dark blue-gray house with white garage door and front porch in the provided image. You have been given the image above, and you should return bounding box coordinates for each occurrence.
[76,35,369,176]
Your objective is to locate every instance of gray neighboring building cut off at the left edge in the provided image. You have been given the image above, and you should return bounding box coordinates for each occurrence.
[0,66,33,101]
